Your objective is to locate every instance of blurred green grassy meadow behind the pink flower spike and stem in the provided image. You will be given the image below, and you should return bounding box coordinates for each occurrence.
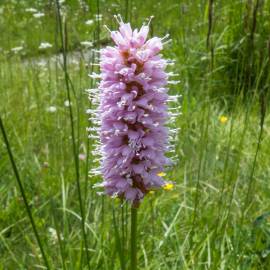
[0,0,270,270]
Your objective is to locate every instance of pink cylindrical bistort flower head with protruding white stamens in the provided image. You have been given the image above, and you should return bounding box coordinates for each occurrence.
[89,16,178,205]
